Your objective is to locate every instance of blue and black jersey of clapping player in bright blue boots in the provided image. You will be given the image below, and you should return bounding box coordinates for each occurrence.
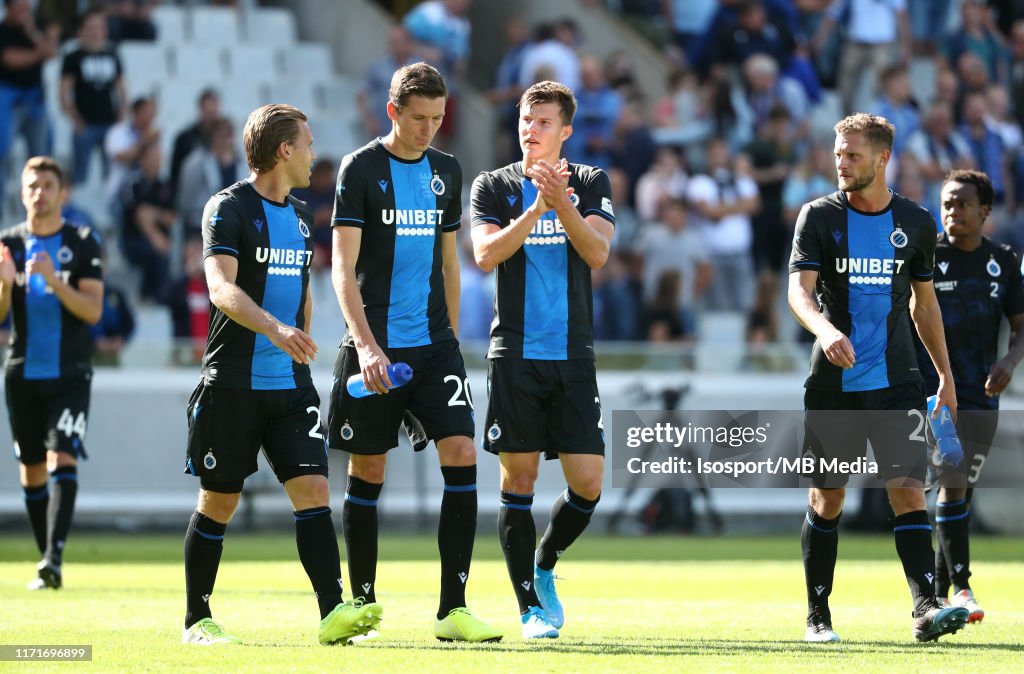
[471,162,615,361]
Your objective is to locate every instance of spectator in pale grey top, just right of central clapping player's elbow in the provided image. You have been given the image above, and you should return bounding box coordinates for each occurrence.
[636,199,713,337]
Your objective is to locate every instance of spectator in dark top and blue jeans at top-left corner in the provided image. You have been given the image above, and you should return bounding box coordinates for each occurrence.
[0,0,60,203]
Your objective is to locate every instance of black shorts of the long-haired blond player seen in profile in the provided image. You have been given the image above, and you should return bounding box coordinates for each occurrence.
[185,383,328,483]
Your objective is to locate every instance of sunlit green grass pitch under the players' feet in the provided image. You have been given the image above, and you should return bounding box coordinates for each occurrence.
[0,530,1024,674]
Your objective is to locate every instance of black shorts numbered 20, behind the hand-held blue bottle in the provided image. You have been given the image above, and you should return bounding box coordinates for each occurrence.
[328,339,476,455]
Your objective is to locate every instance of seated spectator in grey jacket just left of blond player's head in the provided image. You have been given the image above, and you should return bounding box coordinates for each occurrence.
[173,117,245,237]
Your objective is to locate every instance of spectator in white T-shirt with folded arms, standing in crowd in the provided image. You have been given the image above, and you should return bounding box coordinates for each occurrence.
[686,138,761,312]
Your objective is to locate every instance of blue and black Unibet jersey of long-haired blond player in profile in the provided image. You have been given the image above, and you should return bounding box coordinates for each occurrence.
[203,180,313,390]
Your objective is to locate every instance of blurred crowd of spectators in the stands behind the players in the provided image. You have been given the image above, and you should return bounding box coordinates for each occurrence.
[6,0,1024,361]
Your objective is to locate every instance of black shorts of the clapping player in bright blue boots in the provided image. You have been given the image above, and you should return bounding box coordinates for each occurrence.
[483,357,604,459]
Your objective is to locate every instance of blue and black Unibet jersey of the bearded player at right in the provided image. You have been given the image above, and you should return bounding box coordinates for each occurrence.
[790,192,935,391]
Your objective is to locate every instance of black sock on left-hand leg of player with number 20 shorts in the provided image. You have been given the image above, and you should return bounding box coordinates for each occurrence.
[341,475,384,603]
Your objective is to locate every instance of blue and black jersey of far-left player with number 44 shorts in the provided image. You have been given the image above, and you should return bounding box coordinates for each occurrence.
[0,222,103,379]
